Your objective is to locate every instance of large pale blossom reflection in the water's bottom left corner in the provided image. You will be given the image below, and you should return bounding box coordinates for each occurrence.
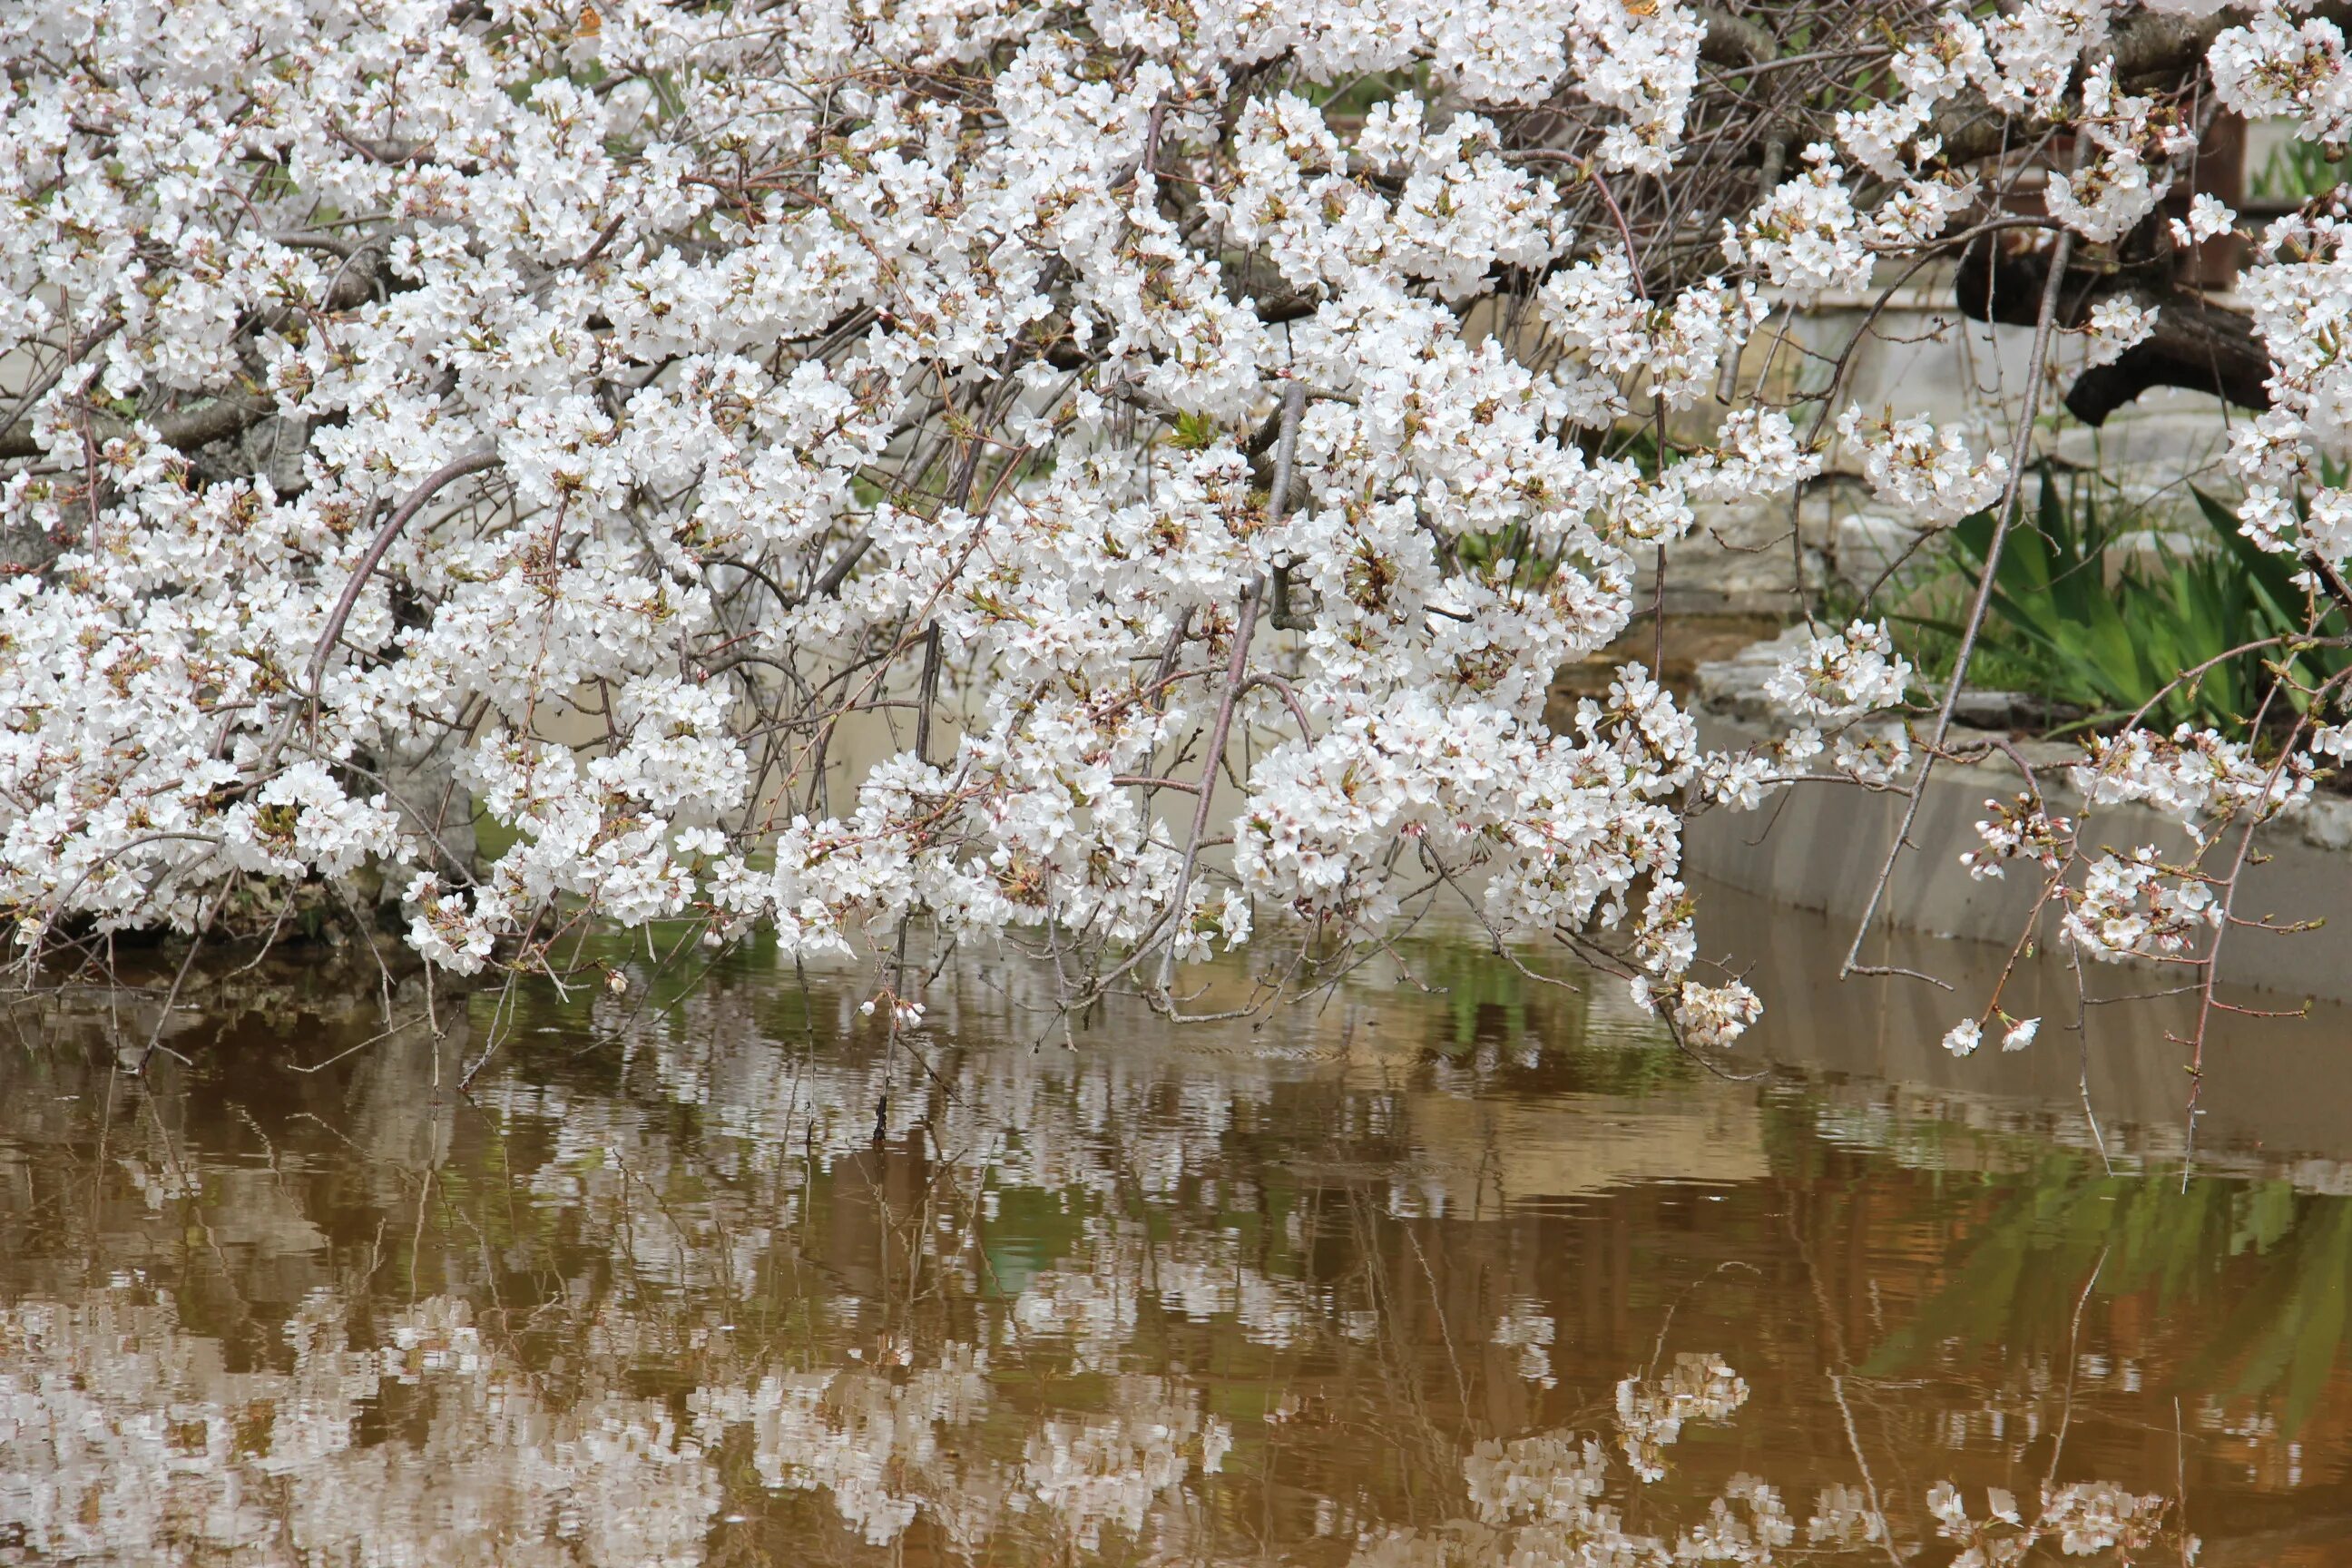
[0,1281,720,1568]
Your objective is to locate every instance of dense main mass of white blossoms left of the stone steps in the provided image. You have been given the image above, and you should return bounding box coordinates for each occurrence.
[0,0,1816,1037]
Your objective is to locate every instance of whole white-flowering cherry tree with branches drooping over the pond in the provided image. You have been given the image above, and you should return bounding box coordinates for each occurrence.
[0,0,2352,1067]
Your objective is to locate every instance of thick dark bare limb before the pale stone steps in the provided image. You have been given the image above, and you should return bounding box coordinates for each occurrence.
[1952,230,2269,426]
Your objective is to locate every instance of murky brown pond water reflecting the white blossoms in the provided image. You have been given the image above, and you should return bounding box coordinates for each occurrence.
[0,905,2352,1568]
